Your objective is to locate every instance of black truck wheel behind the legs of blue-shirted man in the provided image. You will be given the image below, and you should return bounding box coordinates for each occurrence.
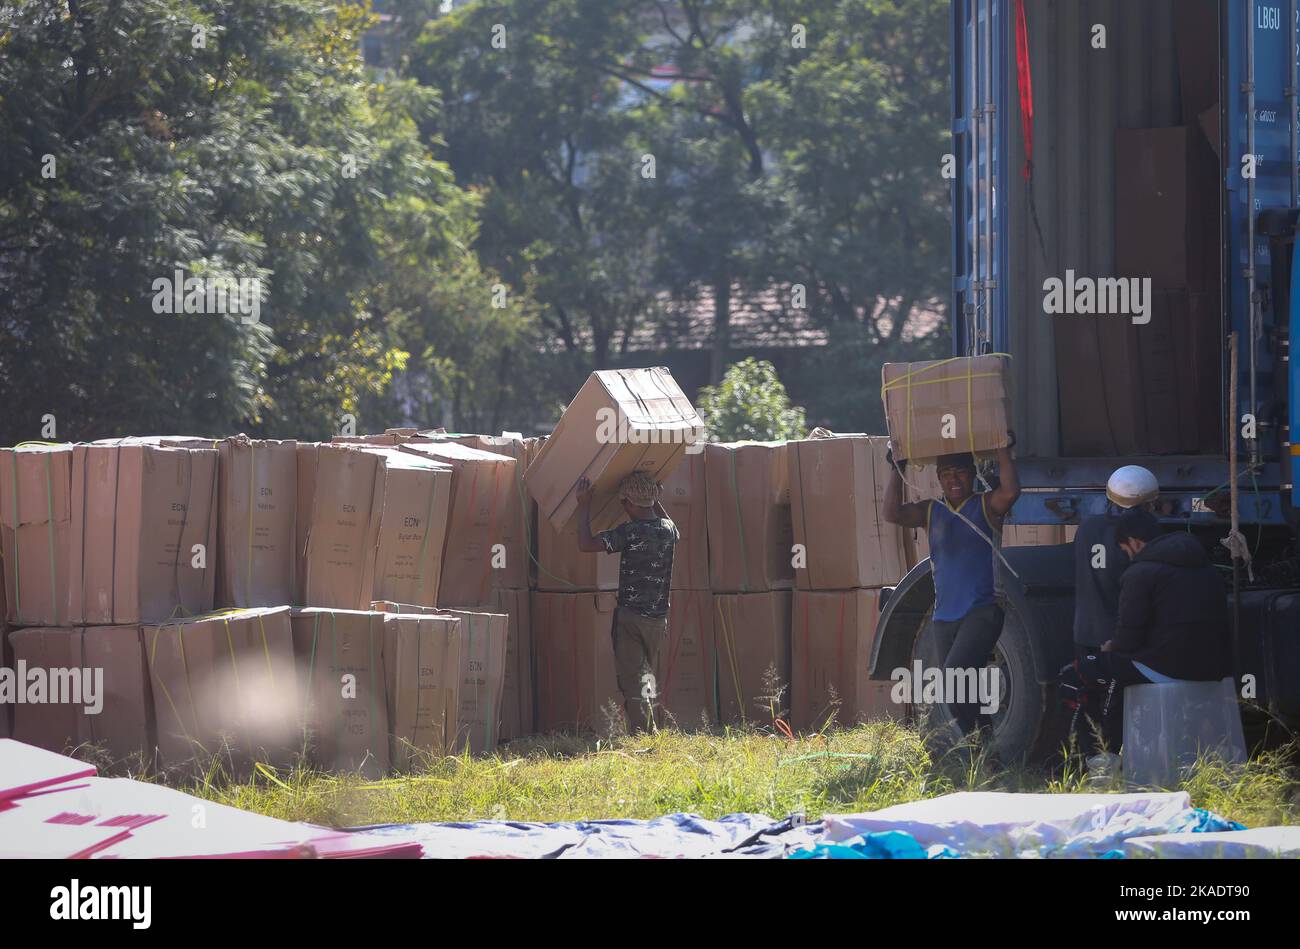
[913,607,1053,764]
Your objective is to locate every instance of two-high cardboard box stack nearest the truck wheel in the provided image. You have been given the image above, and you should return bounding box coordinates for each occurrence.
[788,436,909,731]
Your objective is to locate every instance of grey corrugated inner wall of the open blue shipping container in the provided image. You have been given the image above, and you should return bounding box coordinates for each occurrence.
[1002,0,1180,458]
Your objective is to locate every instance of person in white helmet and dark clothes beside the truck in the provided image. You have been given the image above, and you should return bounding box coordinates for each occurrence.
[1061,464,1160,758]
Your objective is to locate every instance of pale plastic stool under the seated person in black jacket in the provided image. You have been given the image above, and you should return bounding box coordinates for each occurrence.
[1123,679,1245,788]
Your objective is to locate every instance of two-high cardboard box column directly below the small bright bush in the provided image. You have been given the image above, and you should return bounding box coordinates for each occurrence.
[705,442,796,724]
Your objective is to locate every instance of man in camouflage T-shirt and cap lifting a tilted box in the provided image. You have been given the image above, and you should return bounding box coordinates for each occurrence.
[576,471,680,732]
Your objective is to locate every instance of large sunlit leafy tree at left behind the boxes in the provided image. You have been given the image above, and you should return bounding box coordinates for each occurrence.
[0,0,527,443]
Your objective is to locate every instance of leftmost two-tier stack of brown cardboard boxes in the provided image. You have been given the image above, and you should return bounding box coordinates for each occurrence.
[0,438,218,761]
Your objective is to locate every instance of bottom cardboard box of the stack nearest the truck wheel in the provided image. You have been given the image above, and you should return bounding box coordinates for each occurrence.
[790,590,905,731]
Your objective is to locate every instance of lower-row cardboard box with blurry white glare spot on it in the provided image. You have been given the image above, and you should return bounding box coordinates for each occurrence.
[142,606,302,768]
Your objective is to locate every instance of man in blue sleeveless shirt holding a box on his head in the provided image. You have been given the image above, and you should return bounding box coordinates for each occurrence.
[881,447,1021,735]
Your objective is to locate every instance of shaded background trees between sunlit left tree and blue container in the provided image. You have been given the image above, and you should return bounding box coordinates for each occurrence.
[410,0,950,428]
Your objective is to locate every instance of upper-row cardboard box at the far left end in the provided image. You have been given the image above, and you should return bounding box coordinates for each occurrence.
[0,445,73,627]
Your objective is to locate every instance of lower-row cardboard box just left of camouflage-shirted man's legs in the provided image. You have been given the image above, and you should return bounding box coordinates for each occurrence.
[533,593,623,733]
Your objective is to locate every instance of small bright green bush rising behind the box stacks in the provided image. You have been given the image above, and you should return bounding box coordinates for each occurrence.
[696,359,807,442]
